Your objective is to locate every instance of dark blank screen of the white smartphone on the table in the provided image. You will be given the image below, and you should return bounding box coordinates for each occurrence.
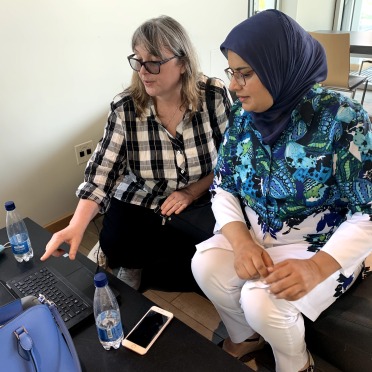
[127,310,168,349]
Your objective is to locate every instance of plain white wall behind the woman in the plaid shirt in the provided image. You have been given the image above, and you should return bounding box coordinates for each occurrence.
[0,0,247,228]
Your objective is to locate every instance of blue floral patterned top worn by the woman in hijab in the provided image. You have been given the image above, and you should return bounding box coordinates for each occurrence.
[211,85,372,260]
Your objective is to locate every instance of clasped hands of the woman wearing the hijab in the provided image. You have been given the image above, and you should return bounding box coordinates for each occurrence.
[234,244,322,301]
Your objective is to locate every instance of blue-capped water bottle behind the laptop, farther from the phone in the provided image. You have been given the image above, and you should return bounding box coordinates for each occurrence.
[5,201,34,262]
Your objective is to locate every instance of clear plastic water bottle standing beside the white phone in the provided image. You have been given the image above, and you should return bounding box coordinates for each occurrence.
[93,273,124,350]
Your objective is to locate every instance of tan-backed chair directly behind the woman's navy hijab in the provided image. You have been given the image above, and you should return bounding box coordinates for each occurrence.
[309,32,368,105]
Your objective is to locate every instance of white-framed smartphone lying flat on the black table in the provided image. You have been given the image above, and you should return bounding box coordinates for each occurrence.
[122,306,173,355]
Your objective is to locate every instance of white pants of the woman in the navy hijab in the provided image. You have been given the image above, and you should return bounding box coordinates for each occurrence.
[191,248,308,372]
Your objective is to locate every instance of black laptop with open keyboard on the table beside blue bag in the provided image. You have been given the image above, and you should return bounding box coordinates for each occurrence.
[0,254,119,330]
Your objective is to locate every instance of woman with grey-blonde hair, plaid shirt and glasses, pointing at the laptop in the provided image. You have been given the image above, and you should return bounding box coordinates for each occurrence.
[42,16,230,290]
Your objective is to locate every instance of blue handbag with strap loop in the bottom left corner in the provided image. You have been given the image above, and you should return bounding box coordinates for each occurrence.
[0,295,81,372]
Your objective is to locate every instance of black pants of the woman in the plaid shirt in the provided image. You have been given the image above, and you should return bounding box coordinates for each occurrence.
[100,198,199,291]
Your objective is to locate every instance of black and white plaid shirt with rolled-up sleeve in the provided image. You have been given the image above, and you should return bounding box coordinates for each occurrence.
[76,77,231,213]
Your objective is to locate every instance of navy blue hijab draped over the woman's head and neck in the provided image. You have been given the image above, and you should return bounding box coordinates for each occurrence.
[220,9,327,145]
